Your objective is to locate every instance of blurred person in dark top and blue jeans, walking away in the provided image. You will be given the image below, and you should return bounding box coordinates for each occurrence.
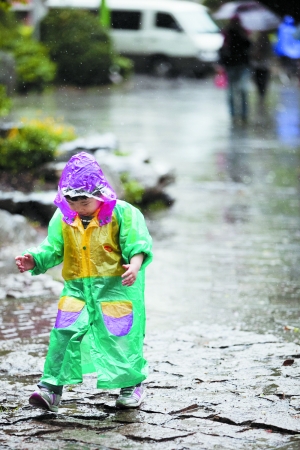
[219,16,251,123]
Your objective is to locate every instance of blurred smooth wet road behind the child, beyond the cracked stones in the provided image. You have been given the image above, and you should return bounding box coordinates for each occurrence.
[15,77,300,342]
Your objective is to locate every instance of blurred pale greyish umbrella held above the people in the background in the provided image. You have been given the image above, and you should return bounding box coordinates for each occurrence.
[213,1,280,31]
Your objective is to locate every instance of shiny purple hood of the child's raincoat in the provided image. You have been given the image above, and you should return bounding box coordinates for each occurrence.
[54,152,117,226]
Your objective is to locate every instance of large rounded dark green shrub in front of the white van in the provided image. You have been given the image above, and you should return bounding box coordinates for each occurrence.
[41,9,114,86]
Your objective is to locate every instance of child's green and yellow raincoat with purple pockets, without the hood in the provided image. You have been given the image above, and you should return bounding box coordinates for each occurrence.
[27,200,152,389]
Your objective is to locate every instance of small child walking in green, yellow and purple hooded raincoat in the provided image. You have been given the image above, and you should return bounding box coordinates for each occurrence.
[16,152,152,412]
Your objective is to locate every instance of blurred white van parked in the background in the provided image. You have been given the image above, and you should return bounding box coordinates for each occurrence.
[46,0,223,76]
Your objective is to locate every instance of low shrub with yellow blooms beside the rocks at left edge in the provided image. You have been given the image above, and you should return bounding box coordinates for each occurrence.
[0,118,75,173]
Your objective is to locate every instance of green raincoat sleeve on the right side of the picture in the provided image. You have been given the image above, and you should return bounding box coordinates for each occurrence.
[115,201,153,269]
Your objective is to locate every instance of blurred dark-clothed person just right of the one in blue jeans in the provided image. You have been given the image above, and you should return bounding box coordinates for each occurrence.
[250,31,273,106]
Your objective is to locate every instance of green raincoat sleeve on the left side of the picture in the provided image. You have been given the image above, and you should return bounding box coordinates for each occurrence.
[25,210,64,275]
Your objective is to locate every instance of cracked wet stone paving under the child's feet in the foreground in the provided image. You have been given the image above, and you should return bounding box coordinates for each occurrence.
[0,322,300,450]
